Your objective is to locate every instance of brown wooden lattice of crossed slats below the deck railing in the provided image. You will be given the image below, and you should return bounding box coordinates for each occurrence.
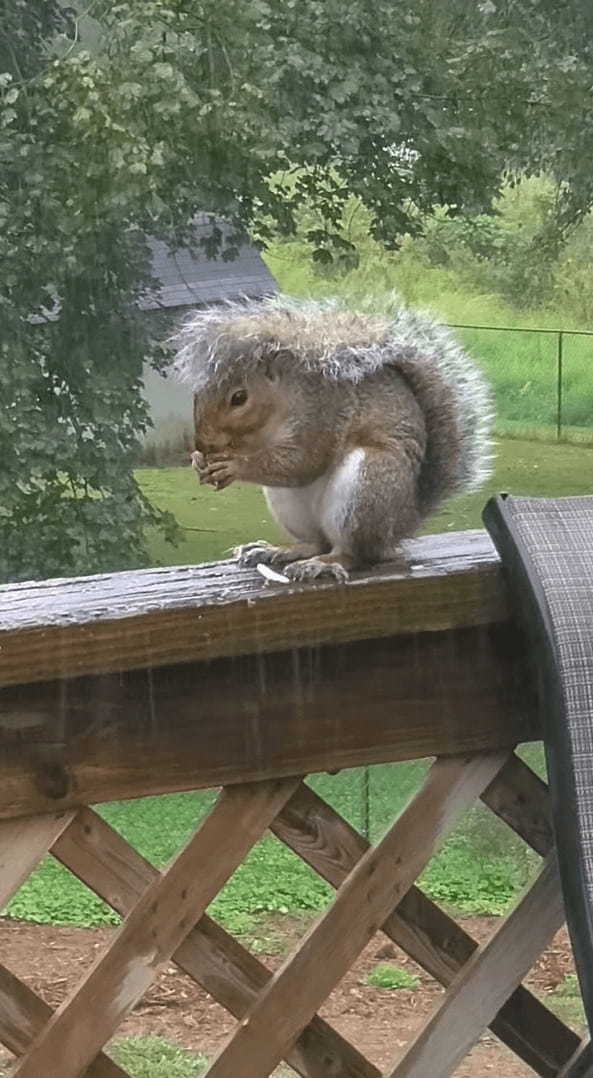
[0,752,579,1078]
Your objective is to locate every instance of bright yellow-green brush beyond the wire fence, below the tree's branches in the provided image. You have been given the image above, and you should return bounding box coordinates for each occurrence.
[266,176,593,329]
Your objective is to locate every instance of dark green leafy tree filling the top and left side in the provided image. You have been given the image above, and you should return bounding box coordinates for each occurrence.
[0,0,593,579]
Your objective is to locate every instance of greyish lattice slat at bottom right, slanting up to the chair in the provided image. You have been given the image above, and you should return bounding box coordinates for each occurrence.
[386,854,564,1078]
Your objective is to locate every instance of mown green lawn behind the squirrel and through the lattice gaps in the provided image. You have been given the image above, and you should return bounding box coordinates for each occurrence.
[4,440,593,937]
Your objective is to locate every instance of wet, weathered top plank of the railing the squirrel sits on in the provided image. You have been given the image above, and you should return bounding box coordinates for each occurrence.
[0,531,509,686]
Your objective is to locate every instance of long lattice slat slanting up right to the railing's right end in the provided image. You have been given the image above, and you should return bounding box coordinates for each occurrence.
[207,755,505,1078]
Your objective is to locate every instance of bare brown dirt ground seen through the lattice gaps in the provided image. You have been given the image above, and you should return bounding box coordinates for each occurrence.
[0,916,586,1078]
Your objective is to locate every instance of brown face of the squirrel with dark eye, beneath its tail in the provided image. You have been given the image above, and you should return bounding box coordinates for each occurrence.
[194,357,288,456]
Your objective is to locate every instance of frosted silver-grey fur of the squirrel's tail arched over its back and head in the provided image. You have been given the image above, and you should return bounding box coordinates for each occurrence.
[174,295,492,498]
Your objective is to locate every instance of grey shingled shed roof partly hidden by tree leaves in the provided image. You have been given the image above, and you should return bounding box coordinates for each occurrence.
[139,215,278,310]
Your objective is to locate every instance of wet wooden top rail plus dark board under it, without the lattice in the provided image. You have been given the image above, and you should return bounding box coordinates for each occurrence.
[0,531,538,817]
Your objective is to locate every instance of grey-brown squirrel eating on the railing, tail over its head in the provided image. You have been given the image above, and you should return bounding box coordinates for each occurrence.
[174,295,492,581]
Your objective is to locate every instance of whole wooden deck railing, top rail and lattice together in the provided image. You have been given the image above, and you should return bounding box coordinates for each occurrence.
[0,533,579,1078]
